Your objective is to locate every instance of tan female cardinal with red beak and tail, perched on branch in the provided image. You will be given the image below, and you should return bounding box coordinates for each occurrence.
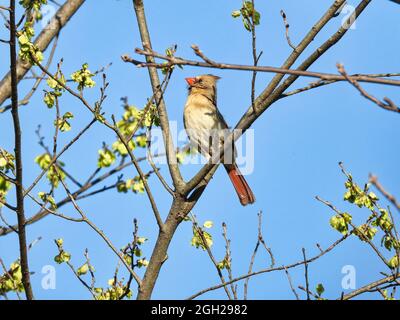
[183,74,255,206]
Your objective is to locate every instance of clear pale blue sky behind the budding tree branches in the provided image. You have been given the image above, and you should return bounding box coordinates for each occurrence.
[0,0,400,299]
